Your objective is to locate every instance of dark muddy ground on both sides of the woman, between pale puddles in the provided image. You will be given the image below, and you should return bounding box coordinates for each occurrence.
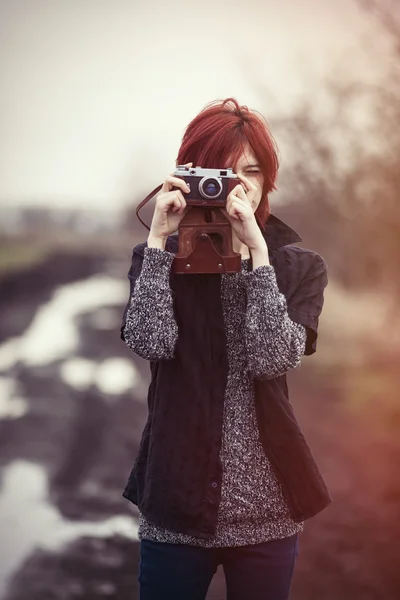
[0,245,400,600]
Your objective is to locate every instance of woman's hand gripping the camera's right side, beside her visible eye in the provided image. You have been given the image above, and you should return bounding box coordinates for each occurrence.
[222,175,265,250]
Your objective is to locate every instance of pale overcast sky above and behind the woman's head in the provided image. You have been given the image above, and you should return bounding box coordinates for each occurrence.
[0,0,394,208]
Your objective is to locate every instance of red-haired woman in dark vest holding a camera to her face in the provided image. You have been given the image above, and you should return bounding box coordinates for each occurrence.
[121,98,331,600]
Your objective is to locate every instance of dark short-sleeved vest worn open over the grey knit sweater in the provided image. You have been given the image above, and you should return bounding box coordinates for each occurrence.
[121,215,332,539]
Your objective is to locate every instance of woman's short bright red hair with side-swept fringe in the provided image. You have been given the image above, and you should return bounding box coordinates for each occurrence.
[176,98,279,228]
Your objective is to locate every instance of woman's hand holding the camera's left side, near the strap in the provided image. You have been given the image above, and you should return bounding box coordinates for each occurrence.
[148,163,193,248]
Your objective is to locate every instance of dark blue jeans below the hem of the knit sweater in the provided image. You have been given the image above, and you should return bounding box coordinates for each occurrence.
[138,533,299,600]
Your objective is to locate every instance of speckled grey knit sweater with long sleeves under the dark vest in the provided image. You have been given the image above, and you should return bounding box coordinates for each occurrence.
[124,247,306,547]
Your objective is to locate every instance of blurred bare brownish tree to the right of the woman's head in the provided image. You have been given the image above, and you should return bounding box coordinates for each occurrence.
[247,0,400,299]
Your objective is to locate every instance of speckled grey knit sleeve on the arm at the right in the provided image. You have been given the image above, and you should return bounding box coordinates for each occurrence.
[245,265,307,379]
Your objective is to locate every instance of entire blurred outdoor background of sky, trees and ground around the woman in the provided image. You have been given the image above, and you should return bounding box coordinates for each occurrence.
[0,0,400,600]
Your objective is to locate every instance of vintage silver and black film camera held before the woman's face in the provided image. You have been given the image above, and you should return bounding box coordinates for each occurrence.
[174,165,241,208]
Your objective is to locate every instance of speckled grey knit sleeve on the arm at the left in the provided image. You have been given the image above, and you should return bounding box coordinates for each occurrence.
[122,247,178,360]
